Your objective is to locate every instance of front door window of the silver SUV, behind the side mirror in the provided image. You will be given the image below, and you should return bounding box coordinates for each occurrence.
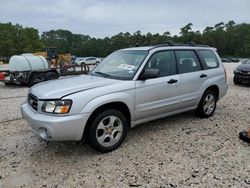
[145,51,176,77]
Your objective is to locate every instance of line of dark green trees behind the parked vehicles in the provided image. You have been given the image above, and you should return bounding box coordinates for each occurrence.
[0,21,250,60]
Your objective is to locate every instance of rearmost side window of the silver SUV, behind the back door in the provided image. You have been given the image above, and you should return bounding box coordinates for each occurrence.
[198,50,219,69]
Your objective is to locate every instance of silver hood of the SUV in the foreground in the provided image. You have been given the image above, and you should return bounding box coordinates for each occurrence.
[30,75,121,99]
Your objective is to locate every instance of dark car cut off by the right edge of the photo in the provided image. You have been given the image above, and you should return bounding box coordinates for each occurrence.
[234,59,250,85]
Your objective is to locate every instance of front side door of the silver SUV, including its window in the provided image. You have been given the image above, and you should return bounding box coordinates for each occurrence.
[135,51,180,121]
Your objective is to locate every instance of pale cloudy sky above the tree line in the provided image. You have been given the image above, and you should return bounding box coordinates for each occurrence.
[0,0,250,38]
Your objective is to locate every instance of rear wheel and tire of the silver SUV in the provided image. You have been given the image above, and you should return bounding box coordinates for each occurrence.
[196,90,218,118]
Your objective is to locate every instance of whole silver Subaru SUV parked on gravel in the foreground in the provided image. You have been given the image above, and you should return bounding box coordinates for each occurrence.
[21,43,228,152]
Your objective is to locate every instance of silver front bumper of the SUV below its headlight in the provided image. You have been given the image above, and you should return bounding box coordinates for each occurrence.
[21,103,89,141]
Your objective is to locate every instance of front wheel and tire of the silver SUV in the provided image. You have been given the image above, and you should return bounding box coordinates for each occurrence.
[86,109,128,153]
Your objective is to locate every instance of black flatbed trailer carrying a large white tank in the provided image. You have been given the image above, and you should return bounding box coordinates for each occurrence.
[0,54,89,87]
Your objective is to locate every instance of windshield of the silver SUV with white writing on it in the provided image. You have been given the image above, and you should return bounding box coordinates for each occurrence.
[91,50,148,80]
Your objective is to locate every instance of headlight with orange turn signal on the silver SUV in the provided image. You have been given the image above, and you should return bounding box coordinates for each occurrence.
[42,100,72,114]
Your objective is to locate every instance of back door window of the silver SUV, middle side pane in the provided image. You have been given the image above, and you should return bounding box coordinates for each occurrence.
[175,50,201,74]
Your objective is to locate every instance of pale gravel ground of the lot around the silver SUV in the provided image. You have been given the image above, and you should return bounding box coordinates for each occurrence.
[0,63,250,188]
